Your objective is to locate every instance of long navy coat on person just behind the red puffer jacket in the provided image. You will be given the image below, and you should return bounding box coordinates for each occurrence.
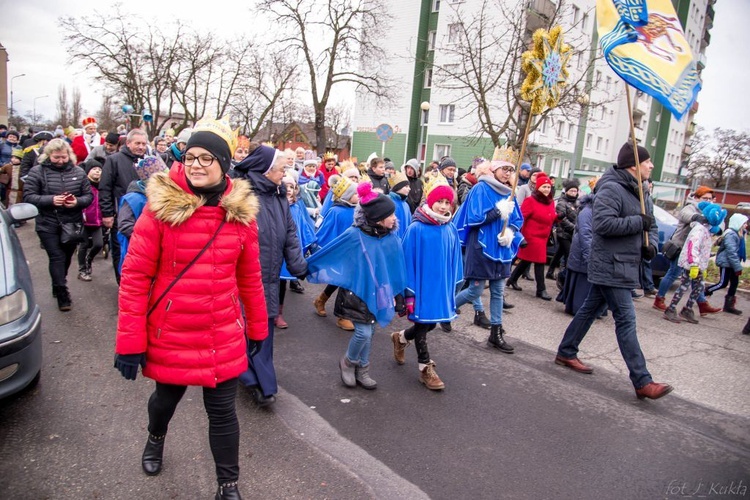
[234,168,307,318]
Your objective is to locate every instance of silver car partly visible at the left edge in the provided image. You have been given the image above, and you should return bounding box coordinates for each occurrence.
[0,203,42,398]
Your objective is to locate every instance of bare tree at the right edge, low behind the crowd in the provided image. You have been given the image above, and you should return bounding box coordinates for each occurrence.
[687,128,750,188]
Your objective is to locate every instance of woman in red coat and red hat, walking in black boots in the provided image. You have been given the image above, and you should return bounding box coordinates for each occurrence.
[508,172,557,300]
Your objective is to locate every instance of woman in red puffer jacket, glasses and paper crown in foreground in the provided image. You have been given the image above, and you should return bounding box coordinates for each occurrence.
[110,120,268,499]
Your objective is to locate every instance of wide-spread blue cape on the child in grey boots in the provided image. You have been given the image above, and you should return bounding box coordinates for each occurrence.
[307,226,406,326]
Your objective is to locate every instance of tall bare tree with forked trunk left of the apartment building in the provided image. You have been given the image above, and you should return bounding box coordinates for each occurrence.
[260,0,391,152]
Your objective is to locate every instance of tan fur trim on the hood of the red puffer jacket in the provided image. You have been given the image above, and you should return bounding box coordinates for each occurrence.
[146,164,259,226]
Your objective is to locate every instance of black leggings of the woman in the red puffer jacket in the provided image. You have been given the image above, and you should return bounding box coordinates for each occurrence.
[148,378,240,484]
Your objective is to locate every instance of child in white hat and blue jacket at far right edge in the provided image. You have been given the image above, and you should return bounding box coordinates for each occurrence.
[706,214,747,315]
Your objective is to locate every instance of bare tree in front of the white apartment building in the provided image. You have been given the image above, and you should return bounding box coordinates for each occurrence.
[431,0,616,147]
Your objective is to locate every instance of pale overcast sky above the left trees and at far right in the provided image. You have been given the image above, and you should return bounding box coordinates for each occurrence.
[0,0,750,132]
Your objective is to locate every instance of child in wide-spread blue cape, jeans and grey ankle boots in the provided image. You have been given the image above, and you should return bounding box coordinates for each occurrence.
[308,183,406,389]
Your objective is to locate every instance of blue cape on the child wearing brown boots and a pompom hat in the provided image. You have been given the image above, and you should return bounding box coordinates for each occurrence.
[403,220,464,323]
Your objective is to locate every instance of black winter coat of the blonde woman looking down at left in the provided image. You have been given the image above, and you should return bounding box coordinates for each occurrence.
[23,161,94,233]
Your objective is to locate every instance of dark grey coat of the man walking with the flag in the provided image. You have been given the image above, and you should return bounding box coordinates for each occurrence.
[588,167,644,288]
